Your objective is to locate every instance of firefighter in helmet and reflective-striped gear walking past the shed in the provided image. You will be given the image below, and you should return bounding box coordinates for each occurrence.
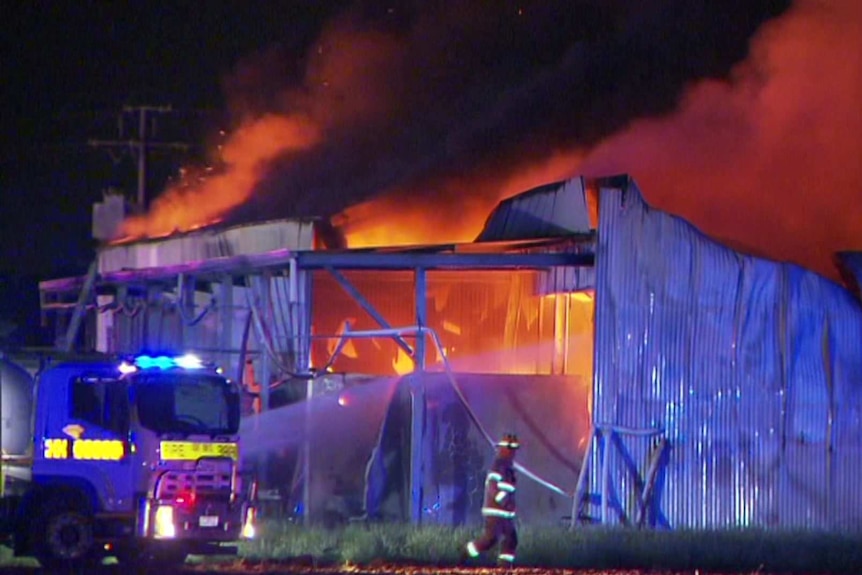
[462,433,519,567]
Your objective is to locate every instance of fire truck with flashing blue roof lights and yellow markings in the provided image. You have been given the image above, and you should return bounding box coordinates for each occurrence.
[0,354,255,568]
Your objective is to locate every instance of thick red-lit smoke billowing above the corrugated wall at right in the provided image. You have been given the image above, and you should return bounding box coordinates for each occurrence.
[581,0,862,278]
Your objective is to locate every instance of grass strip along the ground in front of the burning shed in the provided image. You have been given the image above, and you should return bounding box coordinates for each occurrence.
[235,522,862,574]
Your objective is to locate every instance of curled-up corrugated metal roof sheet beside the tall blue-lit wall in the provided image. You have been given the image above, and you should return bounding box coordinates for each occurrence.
[476,178,592,242]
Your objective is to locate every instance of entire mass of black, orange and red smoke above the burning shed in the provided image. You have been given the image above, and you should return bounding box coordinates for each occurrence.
[116,0,862,275]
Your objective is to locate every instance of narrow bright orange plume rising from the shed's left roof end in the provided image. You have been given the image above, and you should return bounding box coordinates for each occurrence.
[118,115,320,241]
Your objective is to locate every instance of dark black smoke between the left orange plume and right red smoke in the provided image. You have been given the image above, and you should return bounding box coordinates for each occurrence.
[219,0,789,221]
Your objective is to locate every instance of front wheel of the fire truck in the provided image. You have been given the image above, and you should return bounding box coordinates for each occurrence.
[37,509,95,568]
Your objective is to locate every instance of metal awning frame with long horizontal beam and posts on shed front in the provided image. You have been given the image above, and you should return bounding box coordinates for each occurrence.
[39,233,595,522]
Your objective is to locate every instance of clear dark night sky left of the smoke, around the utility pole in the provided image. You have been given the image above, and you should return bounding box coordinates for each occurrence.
[0,0,352,275]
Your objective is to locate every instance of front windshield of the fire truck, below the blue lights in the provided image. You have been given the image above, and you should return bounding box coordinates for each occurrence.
[135,373,240,435]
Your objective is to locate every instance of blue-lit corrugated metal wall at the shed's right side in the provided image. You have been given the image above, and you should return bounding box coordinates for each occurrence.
[586,176,862,529]
